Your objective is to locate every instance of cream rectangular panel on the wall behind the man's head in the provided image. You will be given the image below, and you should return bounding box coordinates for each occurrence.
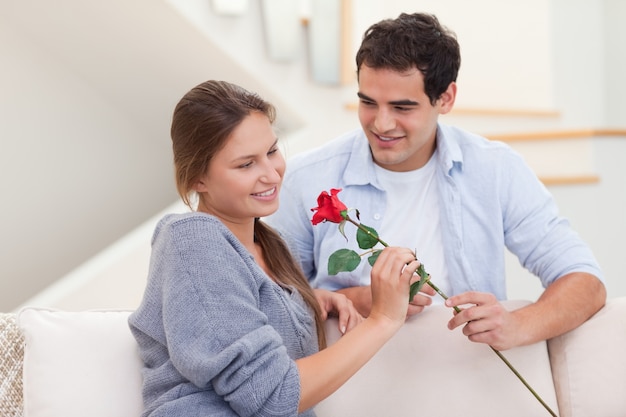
[354,0,555,110]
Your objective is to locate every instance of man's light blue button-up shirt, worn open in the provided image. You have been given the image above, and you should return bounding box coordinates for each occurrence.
[266,124,603,300]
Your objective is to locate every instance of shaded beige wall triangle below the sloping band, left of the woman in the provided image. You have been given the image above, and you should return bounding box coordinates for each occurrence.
[0,18,175,310]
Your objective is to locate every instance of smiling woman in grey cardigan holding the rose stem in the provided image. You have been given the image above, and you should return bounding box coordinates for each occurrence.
[129,81,419,417]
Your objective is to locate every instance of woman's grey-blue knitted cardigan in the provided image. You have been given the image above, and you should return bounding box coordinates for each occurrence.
[129,213,318,417]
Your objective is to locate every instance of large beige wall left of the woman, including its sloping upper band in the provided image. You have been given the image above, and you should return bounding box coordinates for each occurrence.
[0,0,280,311]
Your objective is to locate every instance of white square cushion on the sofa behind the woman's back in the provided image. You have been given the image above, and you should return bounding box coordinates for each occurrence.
[18,308,142,417]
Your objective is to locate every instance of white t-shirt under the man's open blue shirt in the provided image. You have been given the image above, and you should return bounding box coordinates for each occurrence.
[376,151,450,304]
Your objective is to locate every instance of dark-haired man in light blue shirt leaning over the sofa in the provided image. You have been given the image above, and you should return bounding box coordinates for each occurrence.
[268,14,606,350]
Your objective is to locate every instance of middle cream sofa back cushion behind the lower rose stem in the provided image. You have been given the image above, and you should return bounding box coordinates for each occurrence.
[315,301,558,417]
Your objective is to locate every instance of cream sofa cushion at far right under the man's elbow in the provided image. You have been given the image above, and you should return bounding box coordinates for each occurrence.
[548,297,626,417]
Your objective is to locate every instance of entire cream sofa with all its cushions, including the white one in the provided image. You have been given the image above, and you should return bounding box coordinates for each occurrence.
[0,297,626,417]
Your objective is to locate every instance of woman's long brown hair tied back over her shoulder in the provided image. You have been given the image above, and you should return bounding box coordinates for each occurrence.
[171,80,326,349]
